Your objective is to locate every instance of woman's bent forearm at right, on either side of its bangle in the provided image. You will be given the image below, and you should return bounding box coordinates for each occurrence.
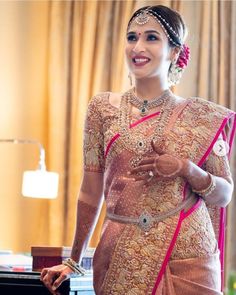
[182,160,233,207]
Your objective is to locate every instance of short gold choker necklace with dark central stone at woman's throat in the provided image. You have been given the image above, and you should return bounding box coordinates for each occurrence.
[130,89,171,117]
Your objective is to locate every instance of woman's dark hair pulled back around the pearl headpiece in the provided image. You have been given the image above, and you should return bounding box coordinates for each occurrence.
[128,5,187,47]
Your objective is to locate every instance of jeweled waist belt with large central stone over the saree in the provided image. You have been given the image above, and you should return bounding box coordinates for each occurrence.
[106,194,197,231]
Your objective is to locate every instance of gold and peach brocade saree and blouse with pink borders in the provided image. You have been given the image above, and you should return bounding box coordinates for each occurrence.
[84,93,235,295]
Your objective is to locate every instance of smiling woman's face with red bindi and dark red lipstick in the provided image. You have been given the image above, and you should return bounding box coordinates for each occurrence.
[125,17,172,79]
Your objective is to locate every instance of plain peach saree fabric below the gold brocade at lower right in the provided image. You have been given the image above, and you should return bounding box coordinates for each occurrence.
[155,253,223,295]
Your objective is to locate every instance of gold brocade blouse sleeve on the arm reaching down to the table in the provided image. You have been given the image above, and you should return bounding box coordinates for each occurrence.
[83,96,105,173]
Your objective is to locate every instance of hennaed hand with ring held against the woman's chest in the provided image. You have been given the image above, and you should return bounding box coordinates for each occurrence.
[130,141,185,183]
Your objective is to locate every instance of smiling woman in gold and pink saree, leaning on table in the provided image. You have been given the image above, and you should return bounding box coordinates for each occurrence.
[41,5,235,295]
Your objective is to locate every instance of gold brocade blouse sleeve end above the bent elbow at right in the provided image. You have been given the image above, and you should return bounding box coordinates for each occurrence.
[204,136,231,177]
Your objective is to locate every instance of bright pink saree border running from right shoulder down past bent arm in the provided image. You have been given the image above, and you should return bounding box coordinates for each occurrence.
[152,112,236,295]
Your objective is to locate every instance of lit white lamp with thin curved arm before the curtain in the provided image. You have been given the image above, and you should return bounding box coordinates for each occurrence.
[0,139,59,199]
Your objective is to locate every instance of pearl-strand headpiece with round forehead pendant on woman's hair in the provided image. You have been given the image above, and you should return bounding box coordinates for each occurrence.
[131,8,182,47]
